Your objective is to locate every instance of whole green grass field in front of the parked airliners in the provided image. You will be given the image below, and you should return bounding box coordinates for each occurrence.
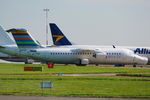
[0,64,150,98]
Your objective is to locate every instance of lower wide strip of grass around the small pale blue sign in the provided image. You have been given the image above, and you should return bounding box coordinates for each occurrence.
[0,76,150,98]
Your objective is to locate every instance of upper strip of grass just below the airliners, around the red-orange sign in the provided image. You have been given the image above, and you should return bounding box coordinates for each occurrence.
[0,64,150,74]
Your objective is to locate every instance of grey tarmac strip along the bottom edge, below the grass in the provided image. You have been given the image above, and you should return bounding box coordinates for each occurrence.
[0,95,150,100]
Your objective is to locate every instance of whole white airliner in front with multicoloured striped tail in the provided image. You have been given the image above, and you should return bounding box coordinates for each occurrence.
[0,25,148,65]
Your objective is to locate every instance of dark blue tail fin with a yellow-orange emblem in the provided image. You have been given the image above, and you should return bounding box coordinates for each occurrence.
[49,23,72,46]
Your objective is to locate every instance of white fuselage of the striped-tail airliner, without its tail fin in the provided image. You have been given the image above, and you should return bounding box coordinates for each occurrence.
[0,46,148,65]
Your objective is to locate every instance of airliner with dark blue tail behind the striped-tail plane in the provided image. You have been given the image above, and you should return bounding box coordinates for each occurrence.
[49,23,150,62]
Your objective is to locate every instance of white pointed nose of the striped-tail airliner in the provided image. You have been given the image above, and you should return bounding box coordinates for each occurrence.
[134,55,148,65]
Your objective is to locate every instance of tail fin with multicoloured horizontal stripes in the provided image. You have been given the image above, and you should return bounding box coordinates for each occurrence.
[7,28,40,48]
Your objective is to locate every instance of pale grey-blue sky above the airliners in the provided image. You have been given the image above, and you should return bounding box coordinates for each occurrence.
[0,0,150,46]
